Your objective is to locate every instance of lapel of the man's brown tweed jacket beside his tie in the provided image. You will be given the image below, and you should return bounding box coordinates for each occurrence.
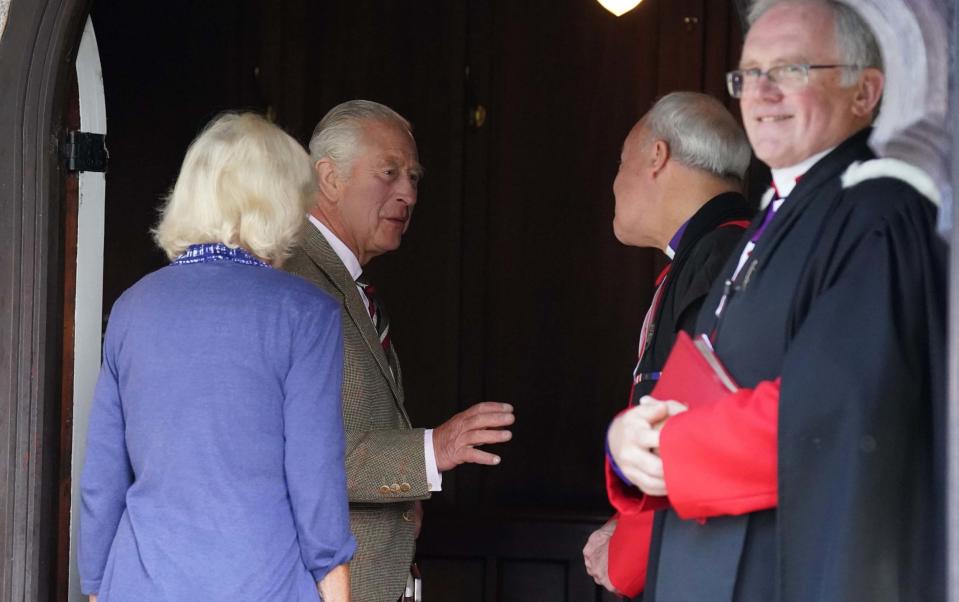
[303,225,408,406]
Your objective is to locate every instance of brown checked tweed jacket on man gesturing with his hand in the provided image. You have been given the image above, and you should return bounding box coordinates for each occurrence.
[283,224,430,602]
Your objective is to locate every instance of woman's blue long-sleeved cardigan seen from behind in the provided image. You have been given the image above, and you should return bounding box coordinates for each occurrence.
[79,261,356,602]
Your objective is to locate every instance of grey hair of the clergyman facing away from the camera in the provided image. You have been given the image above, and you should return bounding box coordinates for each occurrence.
[643,92,752,180]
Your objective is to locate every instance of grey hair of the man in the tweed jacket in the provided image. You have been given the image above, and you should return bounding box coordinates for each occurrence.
[310,100,413,173]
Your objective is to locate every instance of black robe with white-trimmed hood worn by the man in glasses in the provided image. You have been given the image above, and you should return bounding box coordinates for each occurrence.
[645,130,946,602]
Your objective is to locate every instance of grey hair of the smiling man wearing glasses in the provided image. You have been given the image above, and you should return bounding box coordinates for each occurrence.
[748,0,884,86]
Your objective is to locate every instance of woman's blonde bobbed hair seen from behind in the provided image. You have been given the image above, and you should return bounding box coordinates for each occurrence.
[152,113,316,263]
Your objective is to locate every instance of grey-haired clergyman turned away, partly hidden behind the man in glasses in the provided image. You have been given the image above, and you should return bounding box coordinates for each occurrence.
[583,92,753,595]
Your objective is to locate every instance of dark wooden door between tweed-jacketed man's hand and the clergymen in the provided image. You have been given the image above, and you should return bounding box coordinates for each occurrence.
[414,0,738,601]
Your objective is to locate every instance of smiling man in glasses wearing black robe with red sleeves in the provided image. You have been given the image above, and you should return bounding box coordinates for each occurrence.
[608,0,946,602]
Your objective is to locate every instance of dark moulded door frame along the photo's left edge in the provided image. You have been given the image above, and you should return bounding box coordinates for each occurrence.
[0,0,90,602]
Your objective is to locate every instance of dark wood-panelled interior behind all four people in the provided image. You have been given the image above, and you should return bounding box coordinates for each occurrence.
[92,0,762,601]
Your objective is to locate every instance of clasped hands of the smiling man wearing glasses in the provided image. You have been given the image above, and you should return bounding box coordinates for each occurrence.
[607,395,687,496]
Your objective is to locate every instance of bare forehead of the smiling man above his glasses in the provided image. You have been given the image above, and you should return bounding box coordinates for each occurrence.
[739,3,839,67]
